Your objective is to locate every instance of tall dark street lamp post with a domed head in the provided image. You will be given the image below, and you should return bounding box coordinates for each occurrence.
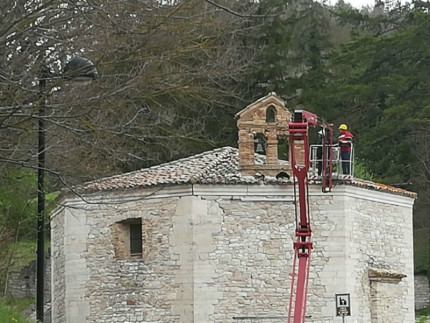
[36,57,97,322]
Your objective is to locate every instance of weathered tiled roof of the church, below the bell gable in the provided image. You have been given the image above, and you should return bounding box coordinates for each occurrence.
[77,147,416,198]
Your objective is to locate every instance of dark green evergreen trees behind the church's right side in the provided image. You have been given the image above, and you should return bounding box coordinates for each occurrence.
[321,3,430,238]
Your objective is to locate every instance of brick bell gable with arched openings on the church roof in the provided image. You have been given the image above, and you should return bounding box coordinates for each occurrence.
[236,92,291,177]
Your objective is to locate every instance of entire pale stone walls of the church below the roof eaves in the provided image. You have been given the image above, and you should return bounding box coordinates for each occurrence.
[52,185,414,323]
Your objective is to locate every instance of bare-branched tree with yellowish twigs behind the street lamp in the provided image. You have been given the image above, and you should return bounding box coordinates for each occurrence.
[0,0,254,184]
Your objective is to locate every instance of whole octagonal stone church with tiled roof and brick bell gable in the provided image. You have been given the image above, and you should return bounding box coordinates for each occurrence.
[51,93,415,323]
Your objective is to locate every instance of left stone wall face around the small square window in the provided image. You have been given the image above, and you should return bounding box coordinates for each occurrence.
[53,194,185,322]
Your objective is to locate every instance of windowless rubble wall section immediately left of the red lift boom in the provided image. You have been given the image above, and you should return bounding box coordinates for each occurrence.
[206,198,294,322]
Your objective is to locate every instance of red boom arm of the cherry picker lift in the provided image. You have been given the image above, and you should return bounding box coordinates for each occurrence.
[288,110,333,323]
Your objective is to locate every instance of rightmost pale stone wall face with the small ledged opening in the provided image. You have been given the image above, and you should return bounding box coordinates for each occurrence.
[346,196,415,323]
